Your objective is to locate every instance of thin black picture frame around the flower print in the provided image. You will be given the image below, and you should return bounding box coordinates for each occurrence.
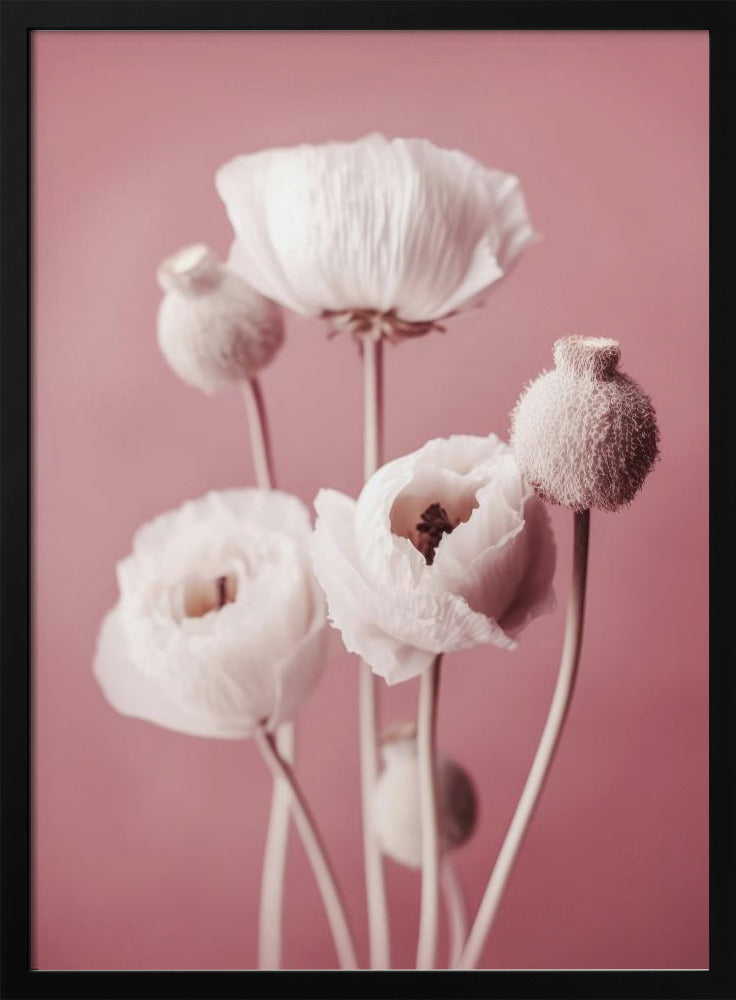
[0,0,736,1000]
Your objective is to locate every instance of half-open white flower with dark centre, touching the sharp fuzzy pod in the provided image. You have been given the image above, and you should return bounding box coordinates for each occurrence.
[312,434,555,684]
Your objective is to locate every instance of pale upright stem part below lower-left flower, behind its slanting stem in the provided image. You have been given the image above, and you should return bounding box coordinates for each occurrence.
[258,722,296,969]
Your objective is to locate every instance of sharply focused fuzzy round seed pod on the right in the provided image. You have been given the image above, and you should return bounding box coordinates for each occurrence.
[511,337,659,511]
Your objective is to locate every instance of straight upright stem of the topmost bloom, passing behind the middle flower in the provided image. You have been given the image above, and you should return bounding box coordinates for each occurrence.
[358,337,391,969]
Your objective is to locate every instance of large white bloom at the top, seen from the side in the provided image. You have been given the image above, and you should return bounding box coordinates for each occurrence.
[215,134,534,333]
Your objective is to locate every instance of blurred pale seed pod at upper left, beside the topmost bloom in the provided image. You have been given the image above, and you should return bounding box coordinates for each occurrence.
[157,243,284,392]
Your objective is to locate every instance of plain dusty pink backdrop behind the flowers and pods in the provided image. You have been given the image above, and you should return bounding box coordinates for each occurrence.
[34,32,708,969]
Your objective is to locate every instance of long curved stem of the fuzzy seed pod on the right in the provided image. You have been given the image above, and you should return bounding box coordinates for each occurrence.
[458,510,590,969]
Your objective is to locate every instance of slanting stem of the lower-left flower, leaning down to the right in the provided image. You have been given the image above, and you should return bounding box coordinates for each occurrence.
[255,729,358,969]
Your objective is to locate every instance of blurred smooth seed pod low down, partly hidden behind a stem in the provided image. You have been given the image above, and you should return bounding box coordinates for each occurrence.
[373,723,478,868]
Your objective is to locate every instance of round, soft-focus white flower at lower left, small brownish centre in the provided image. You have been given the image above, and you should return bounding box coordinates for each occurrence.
[94,489,326,738]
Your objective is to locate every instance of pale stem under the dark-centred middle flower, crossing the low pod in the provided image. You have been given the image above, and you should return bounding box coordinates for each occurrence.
[417,656,442,969]
